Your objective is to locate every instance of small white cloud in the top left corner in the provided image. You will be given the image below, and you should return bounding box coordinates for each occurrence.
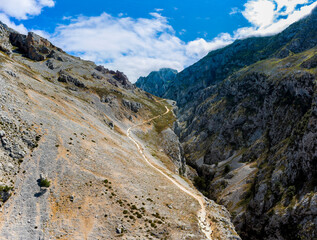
[0,0,55,19]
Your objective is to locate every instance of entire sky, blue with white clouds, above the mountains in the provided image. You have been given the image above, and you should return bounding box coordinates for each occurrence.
[0,0,317,82]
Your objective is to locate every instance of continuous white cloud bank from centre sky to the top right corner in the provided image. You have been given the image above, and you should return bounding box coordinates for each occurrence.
[45,0,316,82]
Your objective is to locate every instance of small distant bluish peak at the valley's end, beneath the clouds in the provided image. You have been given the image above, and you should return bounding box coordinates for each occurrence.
[135,68,177,97]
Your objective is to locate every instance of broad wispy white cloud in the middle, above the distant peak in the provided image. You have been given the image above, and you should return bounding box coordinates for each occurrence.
[51,13,192,81]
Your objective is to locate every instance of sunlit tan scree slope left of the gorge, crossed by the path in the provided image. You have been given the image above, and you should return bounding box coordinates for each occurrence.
[0,21,240,240]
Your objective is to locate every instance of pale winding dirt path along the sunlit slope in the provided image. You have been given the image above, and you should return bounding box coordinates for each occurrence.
[127,101,212,240]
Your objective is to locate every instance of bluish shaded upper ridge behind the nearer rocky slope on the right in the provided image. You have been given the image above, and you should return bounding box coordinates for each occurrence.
[163,6,317,106]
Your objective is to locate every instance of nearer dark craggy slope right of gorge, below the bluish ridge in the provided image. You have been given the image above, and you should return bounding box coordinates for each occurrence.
[181,54,317,239]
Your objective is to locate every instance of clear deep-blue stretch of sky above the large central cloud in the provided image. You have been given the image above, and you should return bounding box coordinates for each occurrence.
[15,0,248,41]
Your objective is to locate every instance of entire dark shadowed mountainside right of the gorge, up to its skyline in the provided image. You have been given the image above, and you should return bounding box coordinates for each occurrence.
[137,6,317,240]
